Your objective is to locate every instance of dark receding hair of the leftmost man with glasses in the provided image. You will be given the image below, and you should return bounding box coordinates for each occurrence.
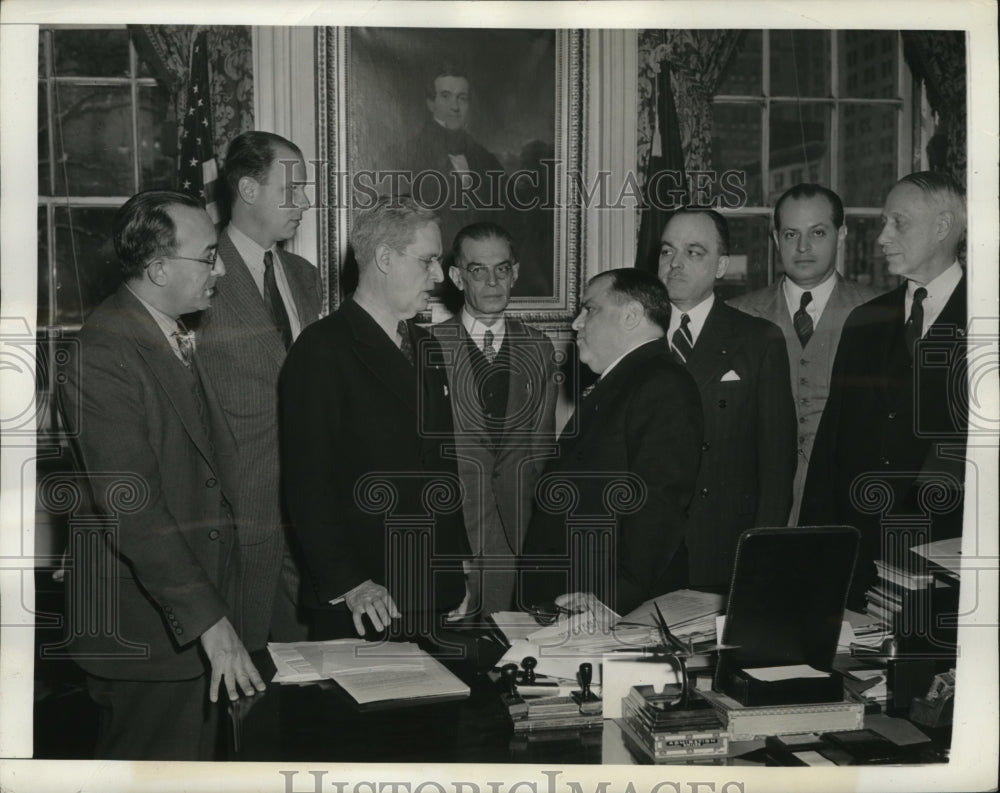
[112,190,205,281]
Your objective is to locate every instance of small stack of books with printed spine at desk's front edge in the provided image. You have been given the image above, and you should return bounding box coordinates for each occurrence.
[621,686,729,763]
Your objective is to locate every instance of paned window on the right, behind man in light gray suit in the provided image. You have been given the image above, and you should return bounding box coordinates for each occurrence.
[712,30,911,296]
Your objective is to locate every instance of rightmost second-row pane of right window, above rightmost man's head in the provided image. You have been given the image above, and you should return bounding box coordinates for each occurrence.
[838,103,899,207]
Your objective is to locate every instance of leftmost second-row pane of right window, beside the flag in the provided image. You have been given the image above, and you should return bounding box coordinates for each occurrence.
[712,104,762,206]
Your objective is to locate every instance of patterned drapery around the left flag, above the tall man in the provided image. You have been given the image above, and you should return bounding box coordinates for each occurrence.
[129,25,253,167]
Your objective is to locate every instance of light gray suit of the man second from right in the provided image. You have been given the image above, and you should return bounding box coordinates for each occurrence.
[728,273,880,526]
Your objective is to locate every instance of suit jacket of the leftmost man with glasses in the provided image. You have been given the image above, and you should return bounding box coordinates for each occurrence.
[62,286,238,680]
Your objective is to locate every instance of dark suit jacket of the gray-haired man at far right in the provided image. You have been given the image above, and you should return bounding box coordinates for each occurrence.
[799,275,968,601]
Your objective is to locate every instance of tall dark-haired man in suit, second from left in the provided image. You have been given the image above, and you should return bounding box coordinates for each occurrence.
[191,132,322,650]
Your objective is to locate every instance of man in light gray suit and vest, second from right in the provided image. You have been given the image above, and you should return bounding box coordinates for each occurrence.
[729,184,878,526]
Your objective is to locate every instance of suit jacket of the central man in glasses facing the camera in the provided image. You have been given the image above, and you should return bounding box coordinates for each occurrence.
[431,315,557,555]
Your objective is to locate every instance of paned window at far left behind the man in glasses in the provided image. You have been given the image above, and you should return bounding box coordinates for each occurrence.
[38,26,177,428]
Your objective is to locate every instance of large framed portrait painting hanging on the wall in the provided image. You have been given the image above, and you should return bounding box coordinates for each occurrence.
[317,27,586,325]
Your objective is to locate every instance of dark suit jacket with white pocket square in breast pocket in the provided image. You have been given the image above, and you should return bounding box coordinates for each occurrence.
[687,298,796,586]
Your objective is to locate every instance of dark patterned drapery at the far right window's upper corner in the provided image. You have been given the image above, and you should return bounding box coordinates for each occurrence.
[903,30,967,185]
